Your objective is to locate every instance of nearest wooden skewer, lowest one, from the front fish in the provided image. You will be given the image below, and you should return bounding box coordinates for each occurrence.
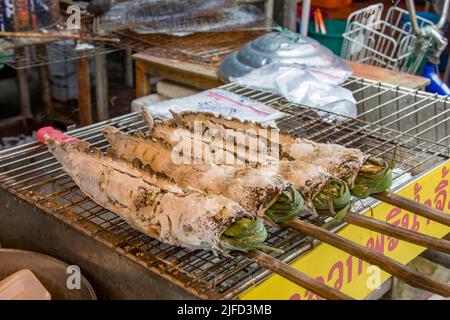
[245,250,353,300]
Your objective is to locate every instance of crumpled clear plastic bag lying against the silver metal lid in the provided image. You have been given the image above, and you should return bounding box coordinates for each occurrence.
[231,63,357,121]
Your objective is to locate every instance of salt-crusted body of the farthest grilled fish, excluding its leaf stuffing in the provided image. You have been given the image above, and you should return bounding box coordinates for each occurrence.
[152,111,367,187]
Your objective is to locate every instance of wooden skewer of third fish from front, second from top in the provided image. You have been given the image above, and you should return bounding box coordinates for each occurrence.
[319,210,450,254]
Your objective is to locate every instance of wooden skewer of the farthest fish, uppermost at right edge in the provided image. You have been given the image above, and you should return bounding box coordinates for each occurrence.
[371,192,450,227]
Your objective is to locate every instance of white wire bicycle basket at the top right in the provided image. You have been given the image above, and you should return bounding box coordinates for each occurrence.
[341,4,433,73]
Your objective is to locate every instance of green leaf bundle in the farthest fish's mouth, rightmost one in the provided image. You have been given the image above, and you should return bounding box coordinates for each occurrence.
[351,157,392,199]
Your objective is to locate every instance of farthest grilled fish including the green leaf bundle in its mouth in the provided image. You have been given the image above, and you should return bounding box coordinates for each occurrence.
[147,112,392,198]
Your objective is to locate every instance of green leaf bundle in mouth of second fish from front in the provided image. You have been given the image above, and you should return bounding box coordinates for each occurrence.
[265,186,305,223]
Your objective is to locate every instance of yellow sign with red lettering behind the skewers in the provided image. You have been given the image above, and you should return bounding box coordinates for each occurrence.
[240,161,450,300]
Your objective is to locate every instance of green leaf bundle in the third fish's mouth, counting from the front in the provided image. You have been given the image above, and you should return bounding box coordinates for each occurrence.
[313,178,351,210]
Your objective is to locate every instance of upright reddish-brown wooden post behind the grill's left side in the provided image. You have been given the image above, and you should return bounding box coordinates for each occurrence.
[77,57,92,126]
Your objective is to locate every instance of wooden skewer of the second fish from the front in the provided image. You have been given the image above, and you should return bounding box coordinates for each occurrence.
[283,219,450,297]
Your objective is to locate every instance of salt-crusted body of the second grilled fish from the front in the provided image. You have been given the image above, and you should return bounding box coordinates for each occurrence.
[103,127,290,218]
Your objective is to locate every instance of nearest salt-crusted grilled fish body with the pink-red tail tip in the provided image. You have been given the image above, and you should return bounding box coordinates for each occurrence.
[47,139,249,251]
